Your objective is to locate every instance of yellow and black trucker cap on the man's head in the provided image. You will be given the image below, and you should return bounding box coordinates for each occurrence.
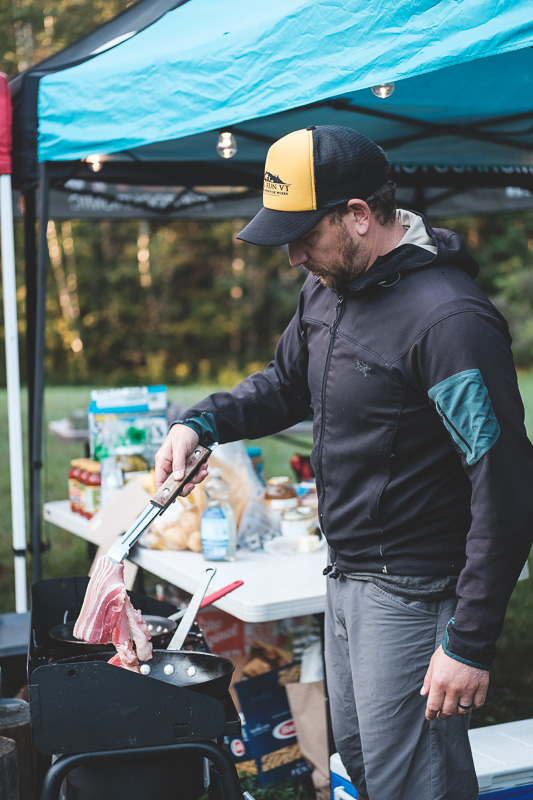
[237,125,390,246]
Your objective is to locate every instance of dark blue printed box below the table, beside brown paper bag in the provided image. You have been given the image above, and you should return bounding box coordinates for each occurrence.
[234,663,311,786]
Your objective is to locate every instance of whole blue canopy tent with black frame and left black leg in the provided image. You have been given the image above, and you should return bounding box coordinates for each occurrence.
[7,0,533,577]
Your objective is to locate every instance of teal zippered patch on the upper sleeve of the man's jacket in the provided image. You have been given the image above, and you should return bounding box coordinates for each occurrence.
[428,369,500,466]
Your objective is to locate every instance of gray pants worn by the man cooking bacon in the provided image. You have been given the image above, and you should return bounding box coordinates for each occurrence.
[325,575,478,800]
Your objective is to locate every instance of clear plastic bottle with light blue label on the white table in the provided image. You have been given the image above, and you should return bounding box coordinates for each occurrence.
[200,469,237,561]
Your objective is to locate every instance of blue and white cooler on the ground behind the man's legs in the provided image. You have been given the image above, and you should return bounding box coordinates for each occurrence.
[330,719,533,800]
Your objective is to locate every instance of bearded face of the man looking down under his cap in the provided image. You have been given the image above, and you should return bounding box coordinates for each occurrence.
[288,215,368,290]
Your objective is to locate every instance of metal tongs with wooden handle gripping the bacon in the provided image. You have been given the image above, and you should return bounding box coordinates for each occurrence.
[106,444,216,564]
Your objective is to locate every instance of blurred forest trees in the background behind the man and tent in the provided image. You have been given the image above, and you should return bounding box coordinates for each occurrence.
[0,0,533,386]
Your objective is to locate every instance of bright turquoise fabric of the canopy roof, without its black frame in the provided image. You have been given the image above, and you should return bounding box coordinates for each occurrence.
[33,0,533,163]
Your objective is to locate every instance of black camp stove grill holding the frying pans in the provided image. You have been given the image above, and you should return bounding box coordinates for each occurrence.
[28,577,243,800]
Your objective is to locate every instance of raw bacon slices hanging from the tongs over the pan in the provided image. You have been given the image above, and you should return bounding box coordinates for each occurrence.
[74,556,152,672]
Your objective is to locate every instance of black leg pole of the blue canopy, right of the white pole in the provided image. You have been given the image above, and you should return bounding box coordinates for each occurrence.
[31,164,49,581]
